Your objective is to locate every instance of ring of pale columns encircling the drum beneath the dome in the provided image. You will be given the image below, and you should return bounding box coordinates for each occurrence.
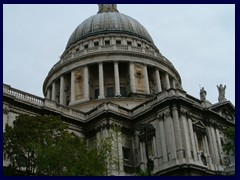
[46,61,179,105]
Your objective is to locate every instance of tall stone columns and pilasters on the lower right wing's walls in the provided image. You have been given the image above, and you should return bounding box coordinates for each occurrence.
[151,106,224,170]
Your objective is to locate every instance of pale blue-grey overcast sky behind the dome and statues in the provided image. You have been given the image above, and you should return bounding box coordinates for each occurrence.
[3,4,235,105]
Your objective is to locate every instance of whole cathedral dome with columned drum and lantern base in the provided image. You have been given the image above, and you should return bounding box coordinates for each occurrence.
[43,4,181,112]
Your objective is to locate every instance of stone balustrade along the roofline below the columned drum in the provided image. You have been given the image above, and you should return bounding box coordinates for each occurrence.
[3,84,191,120]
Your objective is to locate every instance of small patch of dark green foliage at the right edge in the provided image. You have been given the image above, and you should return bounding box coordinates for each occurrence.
[223,127,235,155]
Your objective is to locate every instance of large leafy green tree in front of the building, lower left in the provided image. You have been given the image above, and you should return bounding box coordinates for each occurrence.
[4,115,109,176]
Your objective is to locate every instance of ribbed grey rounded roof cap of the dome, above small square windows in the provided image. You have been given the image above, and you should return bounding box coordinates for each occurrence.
[66,11,153,49]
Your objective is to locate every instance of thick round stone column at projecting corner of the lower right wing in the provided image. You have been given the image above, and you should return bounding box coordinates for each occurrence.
[172,106,184,159]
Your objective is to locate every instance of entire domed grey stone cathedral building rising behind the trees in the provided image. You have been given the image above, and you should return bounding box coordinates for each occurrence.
[3,4,235,175]
